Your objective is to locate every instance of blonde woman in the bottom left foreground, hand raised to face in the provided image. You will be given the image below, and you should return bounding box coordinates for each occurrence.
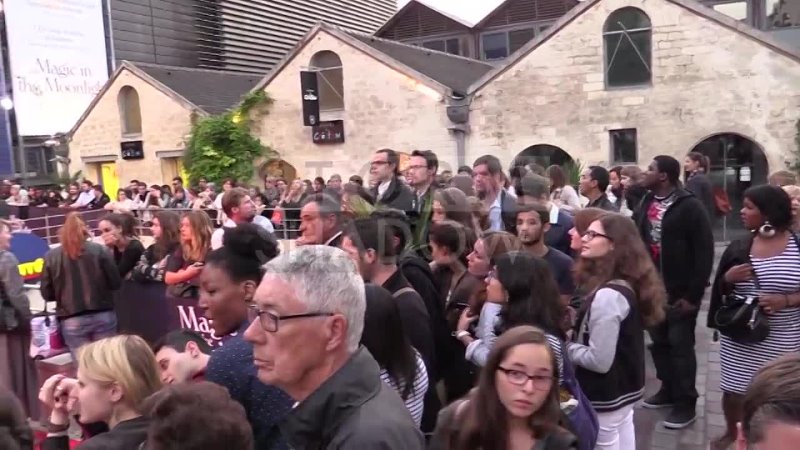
[39,335,161,450]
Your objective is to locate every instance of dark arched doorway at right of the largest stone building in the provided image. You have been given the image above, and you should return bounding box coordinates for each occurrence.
[691,133,769,240]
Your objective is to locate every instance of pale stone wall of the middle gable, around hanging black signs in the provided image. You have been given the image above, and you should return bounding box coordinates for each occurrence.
[255,30,456,180]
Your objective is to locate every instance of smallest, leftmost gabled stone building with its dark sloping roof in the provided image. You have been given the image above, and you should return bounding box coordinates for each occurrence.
[69,62,259,190]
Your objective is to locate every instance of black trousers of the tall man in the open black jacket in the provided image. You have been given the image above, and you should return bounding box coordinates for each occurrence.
[650,311,698,407]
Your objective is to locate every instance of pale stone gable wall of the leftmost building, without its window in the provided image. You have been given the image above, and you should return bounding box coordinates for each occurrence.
[69,69,191,185]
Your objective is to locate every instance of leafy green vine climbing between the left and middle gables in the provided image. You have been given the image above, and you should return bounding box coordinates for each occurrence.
[183,90,275,185]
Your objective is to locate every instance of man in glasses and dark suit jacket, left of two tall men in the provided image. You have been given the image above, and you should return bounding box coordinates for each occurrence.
[369,148,414,214]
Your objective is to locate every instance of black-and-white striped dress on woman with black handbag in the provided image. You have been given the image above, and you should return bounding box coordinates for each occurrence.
[720,238,800,394]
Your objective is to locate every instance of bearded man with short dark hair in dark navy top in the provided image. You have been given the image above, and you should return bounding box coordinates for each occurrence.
[516,204,575,305]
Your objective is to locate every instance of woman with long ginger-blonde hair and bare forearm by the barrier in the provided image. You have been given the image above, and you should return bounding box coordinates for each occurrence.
[164,210,212,298]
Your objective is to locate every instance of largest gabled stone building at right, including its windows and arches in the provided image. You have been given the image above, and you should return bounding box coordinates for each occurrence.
[467,0,800,236]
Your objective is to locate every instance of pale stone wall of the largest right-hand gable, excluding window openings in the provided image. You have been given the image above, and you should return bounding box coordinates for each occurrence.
[467,0,800,171]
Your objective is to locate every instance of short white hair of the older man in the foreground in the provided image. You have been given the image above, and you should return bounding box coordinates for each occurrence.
[264,245,367,353]
